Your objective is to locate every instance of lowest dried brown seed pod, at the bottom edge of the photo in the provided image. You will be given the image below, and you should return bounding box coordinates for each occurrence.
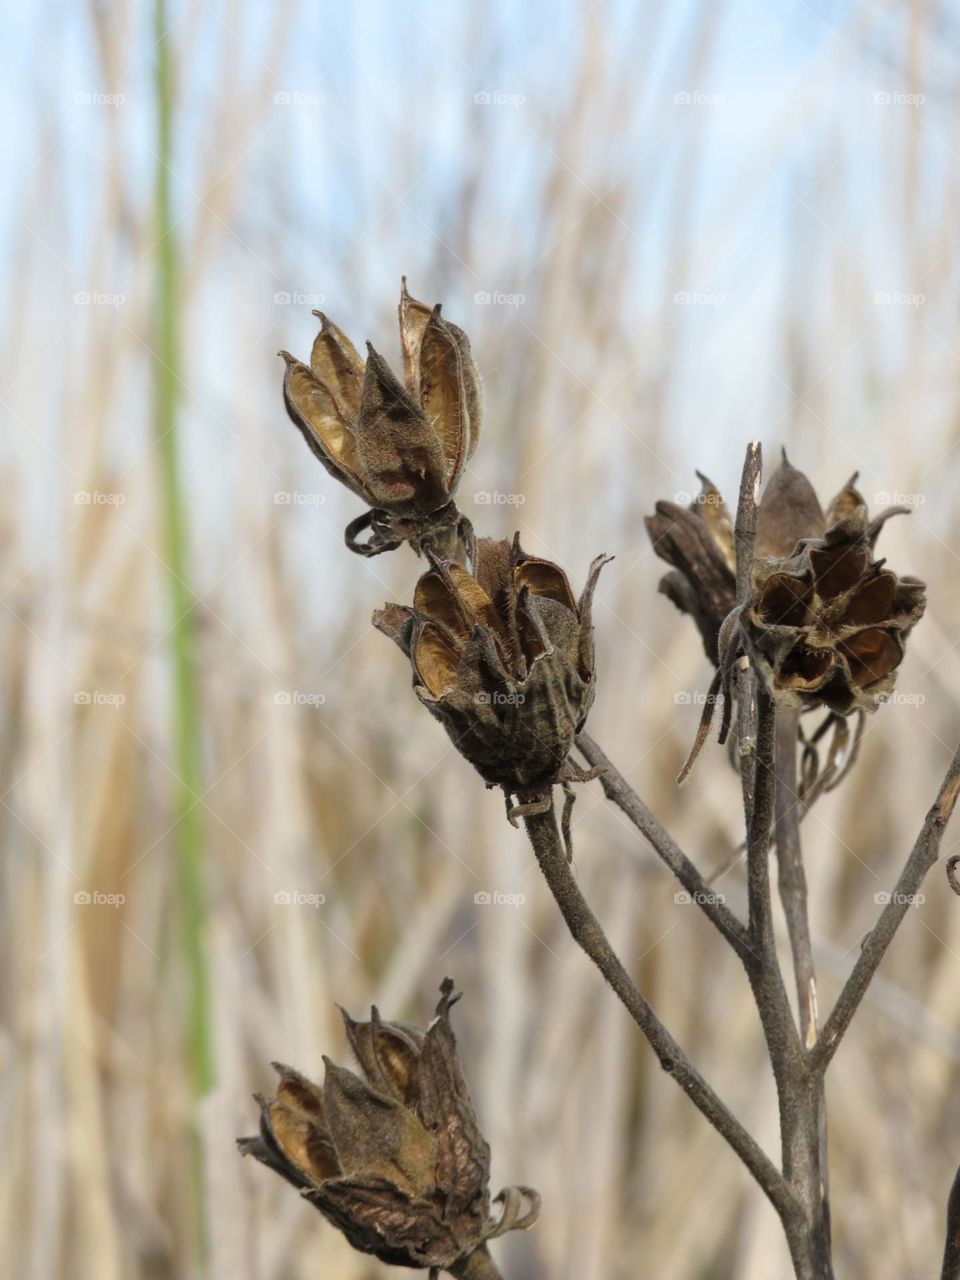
[238,978,540,1277]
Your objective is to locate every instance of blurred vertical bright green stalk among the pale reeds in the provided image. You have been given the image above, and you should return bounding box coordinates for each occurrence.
[154,0,214,1257]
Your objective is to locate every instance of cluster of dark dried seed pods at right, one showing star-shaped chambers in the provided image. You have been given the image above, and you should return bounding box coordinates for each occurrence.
[646,453,925,778]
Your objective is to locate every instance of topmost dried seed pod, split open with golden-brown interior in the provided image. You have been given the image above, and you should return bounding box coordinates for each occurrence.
[280,279,483,562]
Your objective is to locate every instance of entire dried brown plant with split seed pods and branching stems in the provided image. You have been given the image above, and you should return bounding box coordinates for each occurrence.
[241,293,960,1280]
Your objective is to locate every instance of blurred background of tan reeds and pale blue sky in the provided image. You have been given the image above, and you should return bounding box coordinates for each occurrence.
[0,0,960,1280]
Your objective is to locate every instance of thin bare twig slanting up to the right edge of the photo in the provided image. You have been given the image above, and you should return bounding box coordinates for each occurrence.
[812,748,960,1071]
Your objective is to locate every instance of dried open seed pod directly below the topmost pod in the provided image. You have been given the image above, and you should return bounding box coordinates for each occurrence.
[374,535,608,814]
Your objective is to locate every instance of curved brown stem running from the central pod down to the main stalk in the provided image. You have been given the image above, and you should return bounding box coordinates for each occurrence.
[524,810,797,1219]
